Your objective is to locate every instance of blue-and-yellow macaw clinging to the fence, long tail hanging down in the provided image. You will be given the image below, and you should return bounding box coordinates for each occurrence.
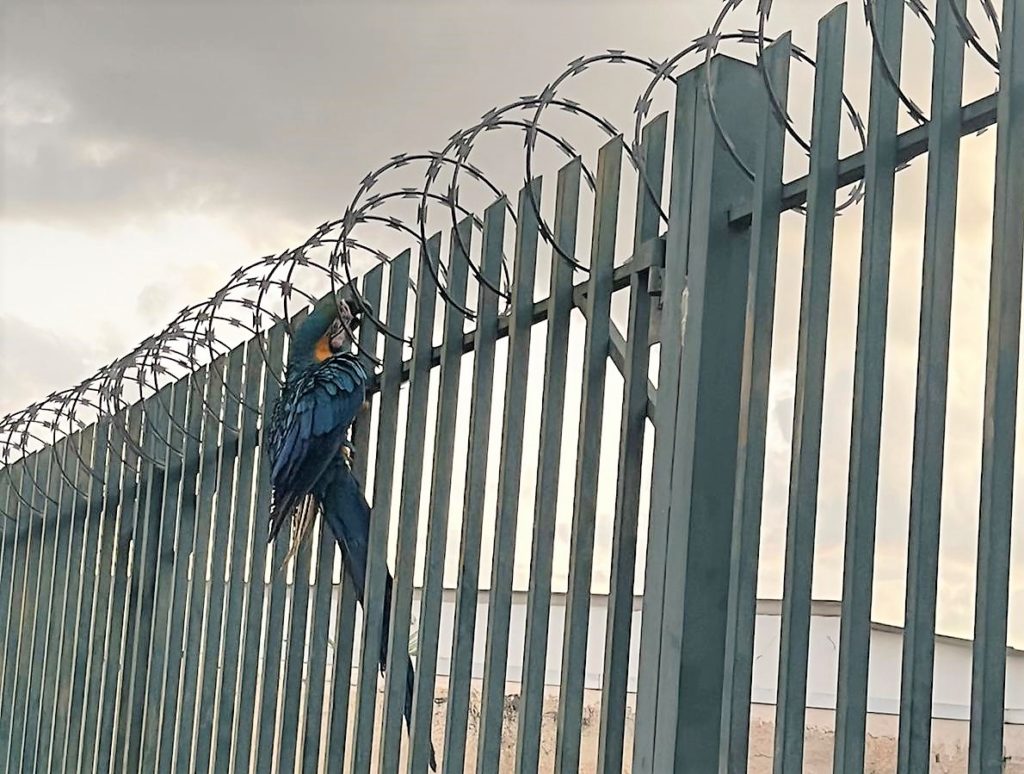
[267,294,437,771]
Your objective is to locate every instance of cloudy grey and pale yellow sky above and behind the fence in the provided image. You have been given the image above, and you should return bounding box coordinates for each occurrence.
[0,0,1024,647]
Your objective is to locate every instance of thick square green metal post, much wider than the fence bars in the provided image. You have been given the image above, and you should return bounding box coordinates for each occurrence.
[633,56,768,772]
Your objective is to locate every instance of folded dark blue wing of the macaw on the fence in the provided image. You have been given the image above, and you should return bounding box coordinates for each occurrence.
[268,356,366,540]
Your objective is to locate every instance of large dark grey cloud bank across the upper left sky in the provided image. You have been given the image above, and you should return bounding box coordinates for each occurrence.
[4,4,667,224]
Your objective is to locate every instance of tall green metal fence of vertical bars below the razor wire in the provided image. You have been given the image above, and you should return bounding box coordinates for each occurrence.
[0,0,1024,774]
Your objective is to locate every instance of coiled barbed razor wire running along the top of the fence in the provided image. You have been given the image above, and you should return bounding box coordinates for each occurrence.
[0,0,999,518]
